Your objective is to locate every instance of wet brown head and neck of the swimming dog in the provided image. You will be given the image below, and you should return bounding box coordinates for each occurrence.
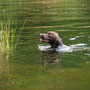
[40,31,63,48]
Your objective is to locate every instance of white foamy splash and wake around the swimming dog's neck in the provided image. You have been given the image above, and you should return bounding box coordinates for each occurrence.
[38,43,90,52]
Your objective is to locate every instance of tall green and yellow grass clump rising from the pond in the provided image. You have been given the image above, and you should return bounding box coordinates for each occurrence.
[0,20,16,53]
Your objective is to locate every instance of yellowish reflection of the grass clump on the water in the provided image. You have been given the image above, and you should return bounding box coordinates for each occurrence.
[0,52,10,88]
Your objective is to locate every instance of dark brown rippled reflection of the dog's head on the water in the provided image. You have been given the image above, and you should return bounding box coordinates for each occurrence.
[41,51,60,66]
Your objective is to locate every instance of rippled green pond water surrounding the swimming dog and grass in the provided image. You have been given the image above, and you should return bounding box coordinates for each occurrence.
[0,0,90,90]
